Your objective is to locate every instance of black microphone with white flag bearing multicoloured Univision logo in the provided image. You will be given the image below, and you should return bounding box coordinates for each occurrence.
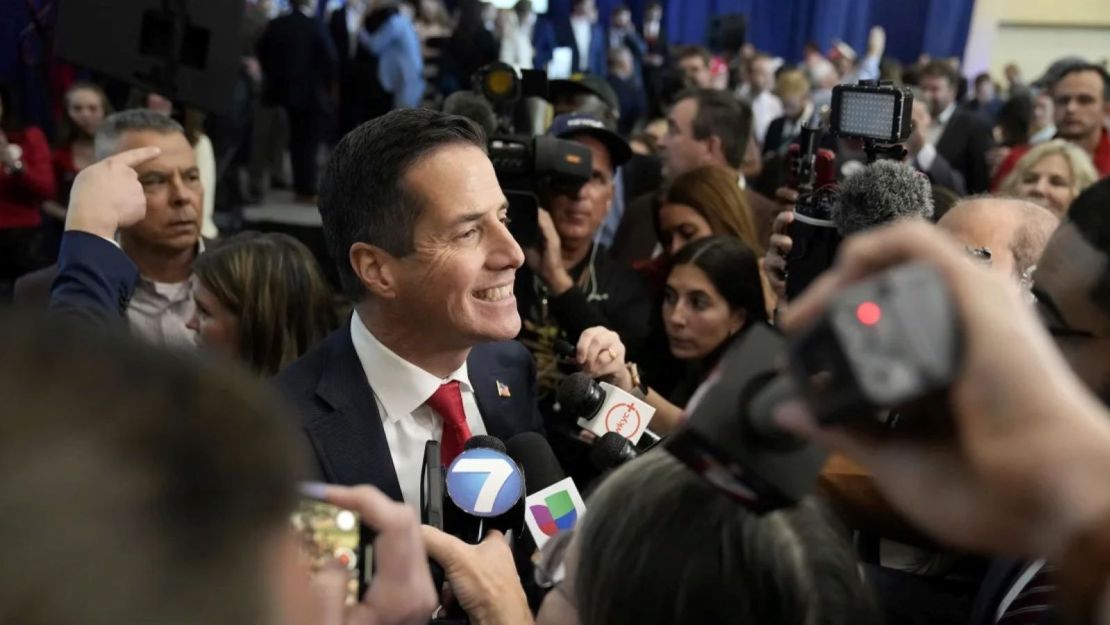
[506,432,586,548]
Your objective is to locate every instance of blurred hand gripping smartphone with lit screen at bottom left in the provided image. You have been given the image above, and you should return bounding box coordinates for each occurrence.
[323,485,438,625]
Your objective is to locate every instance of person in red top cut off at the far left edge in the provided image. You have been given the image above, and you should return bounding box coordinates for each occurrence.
[0,84,54,292]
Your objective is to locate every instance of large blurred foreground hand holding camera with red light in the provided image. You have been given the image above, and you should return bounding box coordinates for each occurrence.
[776,223,1110,556]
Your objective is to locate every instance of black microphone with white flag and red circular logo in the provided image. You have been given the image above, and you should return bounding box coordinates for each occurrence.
[556,372,655,444]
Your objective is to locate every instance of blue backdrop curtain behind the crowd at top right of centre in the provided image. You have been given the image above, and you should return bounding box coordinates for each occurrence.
[548,0,975,63]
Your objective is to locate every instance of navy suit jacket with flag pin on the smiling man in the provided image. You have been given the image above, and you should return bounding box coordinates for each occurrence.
[274,322,543,501]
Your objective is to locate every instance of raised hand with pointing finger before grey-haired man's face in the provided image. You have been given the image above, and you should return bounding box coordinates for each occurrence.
[65,148,162,239]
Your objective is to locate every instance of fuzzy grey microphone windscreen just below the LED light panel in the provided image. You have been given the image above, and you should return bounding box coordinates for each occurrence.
[833,160,932,236]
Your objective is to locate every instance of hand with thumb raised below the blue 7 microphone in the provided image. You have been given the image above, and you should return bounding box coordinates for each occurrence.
[421,525,532,625]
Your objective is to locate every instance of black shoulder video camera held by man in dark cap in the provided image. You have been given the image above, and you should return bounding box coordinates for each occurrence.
[472,62,593,248]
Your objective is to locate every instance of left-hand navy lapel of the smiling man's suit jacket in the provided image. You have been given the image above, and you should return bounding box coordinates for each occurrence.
[305,322,402,501]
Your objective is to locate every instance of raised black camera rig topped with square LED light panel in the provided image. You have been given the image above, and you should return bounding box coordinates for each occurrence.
[786,80,914,300]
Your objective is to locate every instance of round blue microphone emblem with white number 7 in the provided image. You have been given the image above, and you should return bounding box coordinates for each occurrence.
[446,447,524,516]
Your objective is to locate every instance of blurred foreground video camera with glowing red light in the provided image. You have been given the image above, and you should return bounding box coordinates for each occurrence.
[663,263,962,513]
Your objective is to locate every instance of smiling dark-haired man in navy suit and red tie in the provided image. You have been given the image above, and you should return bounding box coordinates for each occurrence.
[276,109,542,505]
